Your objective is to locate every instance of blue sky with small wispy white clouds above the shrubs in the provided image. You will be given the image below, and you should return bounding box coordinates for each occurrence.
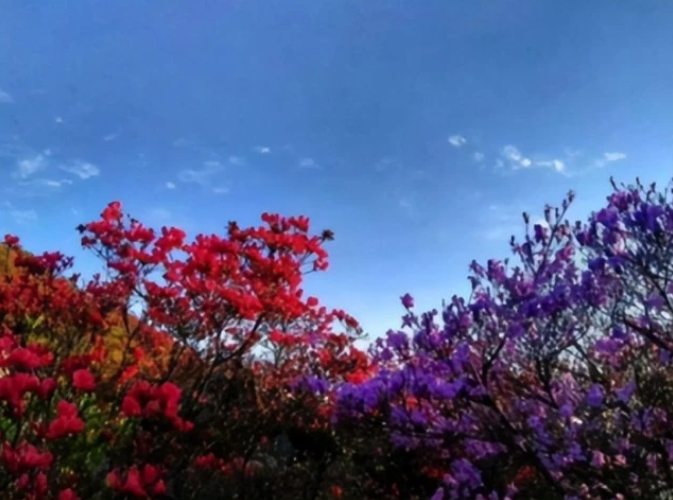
[0,0,673,335]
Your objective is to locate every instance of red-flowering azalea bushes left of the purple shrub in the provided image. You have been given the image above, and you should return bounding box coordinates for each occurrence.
[0,203,372,500]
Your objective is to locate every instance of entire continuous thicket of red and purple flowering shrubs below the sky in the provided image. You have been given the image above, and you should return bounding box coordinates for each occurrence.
[0,178,673,500]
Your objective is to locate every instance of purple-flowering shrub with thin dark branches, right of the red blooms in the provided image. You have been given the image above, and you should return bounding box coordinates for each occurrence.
[335,178,673,500]
